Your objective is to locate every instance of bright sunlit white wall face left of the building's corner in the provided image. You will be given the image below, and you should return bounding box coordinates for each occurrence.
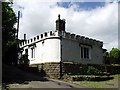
[28,37,60,64]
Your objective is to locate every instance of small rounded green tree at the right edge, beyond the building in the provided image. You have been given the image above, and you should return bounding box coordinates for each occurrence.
[109,48,120,63]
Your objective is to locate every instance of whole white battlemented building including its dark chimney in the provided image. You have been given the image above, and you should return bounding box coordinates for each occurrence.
[19,15,103,65]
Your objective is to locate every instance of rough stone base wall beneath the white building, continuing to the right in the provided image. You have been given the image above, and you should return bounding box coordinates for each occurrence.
[30,63,120,79]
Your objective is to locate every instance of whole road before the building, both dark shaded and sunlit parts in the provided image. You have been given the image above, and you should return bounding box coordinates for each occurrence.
[2,64,84,90]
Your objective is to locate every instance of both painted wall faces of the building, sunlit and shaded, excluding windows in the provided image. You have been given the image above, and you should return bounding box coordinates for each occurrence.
[21,31,103,64]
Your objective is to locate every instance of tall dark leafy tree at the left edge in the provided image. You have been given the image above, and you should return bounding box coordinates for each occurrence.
[2,2,17,64]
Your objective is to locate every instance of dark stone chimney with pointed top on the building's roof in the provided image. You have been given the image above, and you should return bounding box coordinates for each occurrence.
[56,14,65,31]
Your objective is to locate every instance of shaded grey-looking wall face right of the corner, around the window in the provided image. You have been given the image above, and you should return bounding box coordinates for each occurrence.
[62,39,103,64]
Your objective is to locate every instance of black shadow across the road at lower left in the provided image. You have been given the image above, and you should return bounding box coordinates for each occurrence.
[2,64,48,88]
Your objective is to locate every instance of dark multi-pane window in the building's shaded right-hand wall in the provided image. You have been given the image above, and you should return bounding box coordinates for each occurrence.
[81,47,90,59]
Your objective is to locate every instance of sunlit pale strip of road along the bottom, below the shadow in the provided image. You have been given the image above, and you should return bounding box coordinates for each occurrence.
[8,79,85,88]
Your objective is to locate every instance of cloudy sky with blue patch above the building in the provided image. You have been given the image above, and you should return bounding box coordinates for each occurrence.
[13,0,118,51]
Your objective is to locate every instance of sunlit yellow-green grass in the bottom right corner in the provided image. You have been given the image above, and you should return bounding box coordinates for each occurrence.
[73,74,120,88]
